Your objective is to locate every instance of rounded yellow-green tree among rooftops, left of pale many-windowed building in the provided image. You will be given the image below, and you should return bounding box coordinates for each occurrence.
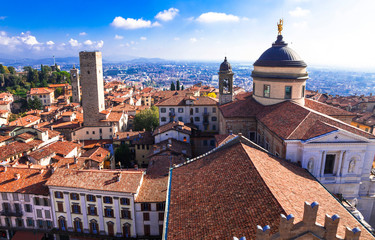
[134,106,159,131]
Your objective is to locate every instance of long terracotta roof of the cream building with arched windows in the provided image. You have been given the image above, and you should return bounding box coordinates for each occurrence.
[47,168,143,193]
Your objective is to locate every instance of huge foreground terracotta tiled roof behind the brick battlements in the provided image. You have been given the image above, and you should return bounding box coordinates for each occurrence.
[168,140,373,239]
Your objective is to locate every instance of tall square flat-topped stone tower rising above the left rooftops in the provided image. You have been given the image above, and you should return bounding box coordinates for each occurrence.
[79,51,106,126]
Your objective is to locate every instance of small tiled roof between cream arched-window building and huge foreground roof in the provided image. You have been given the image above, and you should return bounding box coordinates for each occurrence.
[135,175,168,202]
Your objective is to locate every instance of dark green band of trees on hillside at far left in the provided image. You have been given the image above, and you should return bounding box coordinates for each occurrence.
[0,64,70,97]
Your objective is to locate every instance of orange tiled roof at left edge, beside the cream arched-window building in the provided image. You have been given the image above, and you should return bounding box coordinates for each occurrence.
[0,167,51,195]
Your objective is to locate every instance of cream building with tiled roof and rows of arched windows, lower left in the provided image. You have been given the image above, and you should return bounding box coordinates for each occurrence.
[46,169,144,237]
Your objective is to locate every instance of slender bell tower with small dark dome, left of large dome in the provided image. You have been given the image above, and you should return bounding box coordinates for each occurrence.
[218,57,234,105]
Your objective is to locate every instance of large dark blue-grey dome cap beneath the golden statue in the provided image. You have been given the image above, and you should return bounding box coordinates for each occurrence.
[254,35,307,69]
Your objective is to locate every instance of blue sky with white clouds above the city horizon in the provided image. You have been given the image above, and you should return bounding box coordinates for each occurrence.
[0,0,375,70]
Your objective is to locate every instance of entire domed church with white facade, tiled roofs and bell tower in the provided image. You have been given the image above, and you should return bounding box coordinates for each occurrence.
[219,33,375,225]
